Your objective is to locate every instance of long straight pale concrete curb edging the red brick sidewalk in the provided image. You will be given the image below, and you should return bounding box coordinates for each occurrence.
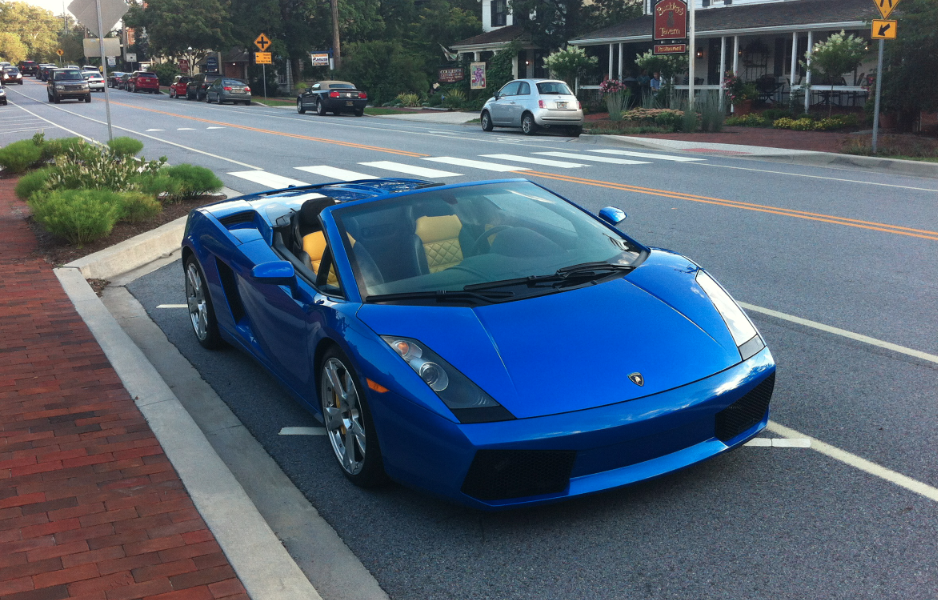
[54,268,321,600]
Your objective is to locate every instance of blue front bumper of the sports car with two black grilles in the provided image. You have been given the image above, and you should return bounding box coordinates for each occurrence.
[371,349,775,510]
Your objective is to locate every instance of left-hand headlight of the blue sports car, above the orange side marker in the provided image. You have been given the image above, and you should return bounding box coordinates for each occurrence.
[381,335,515,423]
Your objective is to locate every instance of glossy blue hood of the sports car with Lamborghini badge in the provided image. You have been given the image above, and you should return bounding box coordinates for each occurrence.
[359,253,740,418]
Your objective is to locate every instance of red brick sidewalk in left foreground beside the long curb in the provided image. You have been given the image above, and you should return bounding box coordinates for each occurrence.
[0,180,248,600]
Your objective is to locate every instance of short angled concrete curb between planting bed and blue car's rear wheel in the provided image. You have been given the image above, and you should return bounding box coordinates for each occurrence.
[64,187,241,279]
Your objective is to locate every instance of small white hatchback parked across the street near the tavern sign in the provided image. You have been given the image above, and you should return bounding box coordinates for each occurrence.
[479,79,583,136]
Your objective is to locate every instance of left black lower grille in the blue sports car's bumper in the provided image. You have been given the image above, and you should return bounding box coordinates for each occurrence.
[462,450,576,500]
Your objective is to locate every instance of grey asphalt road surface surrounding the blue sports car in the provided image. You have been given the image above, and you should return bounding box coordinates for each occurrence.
[0,80,938,599]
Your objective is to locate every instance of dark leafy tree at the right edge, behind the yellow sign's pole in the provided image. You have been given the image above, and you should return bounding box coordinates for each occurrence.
[882,0,938,131]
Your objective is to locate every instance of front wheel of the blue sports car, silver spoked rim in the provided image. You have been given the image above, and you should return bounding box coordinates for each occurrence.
[319,347,387,487]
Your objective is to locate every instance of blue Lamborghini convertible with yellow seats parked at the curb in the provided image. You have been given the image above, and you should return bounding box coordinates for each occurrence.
[182,179,775,509]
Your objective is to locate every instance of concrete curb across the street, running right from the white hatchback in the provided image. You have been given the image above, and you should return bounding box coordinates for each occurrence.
[580,134,938,179]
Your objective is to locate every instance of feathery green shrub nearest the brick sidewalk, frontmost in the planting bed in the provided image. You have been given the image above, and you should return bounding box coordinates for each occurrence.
[29,190,122,248]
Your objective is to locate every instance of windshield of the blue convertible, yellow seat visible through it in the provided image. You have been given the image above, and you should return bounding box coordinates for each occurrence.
[332,182,641,301]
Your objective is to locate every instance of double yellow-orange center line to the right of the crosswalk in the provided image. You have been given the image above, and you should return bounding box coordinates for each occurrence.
[518,171,938,241]
